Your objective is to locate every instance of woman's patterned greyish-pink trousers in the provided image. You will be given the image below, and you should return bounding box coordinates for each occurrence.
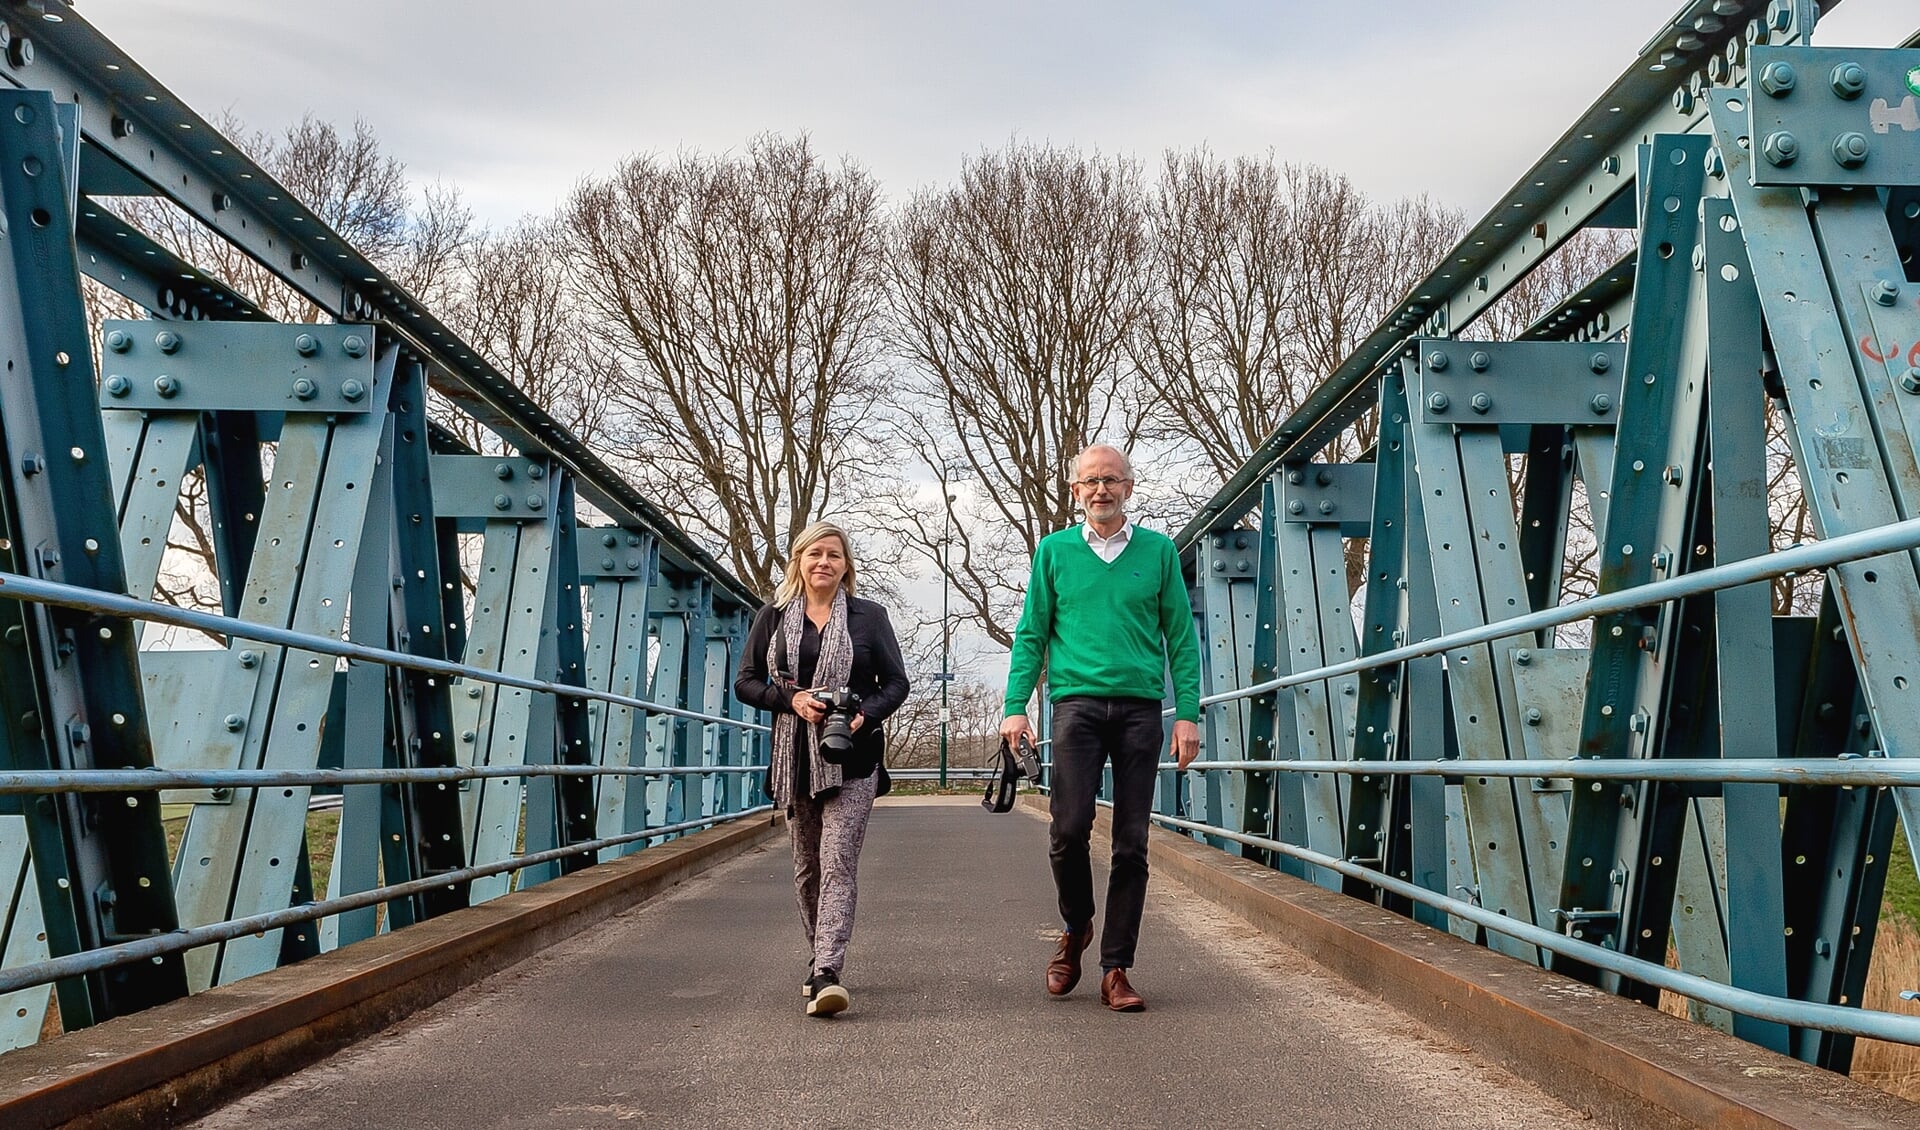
[787,773,879,973]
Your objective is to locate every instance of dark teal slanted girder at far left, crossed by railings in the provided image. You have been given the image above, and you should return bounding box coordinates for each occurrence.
[0,90,186,1028]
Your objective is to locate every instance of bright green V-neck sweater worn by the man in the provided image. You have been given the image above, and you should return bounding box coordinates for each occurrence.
[1006,526,1200,721]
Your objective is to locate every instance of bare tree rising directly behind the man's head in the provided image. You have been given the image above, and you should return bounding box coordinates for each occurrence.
[891,144,1146,647]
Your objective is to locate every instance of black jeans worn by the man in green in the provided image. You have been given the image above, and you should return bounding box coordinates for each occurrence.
[1048,694,1165,969]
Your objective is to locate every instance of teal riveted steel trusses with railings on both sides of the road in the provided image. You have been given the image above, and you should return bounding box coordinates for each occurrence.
[0,0,1920,1112]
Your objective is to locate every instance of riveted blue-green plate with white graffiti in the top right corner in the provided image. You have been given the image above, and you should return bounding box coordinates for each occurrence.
[1747,46,1920,186]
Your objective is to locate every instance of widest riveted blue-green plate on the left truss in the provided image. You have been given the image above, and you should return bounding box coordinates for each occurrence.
[100,320,374,414]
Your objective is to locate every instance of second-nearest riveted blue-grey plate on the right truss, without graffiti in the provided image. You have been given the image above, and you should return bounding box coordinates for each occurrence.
[1409,338,1626,428]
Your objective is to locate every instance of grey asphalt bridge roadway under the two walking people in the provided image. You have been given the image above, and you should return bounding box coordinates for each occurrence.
[187,798,1584,1130]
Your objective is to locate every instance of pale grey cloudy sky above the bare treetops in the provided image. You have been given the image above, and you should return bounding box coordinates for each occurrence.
[67,0,1920,223]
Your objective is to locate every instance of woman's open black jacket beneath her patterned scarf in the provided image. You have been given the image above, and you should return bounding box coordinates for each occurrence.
[733,597,908,781]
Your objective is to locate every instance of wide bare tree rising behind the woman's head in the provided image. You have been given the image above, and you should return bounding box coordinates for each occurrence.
[563,134,893,593]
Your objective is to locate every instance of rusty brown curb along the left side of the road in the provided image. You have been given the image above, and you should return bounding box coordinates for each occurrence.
[0,817,783,1130]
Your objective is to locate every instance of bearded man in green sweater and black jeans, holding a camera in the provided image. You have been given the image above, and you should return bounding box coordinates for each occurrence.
[1000,443,1200,1013]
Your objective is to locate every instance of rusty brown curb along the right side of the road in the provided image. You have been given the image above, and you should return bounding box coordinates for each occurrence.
[1025,796,1920,1130]
